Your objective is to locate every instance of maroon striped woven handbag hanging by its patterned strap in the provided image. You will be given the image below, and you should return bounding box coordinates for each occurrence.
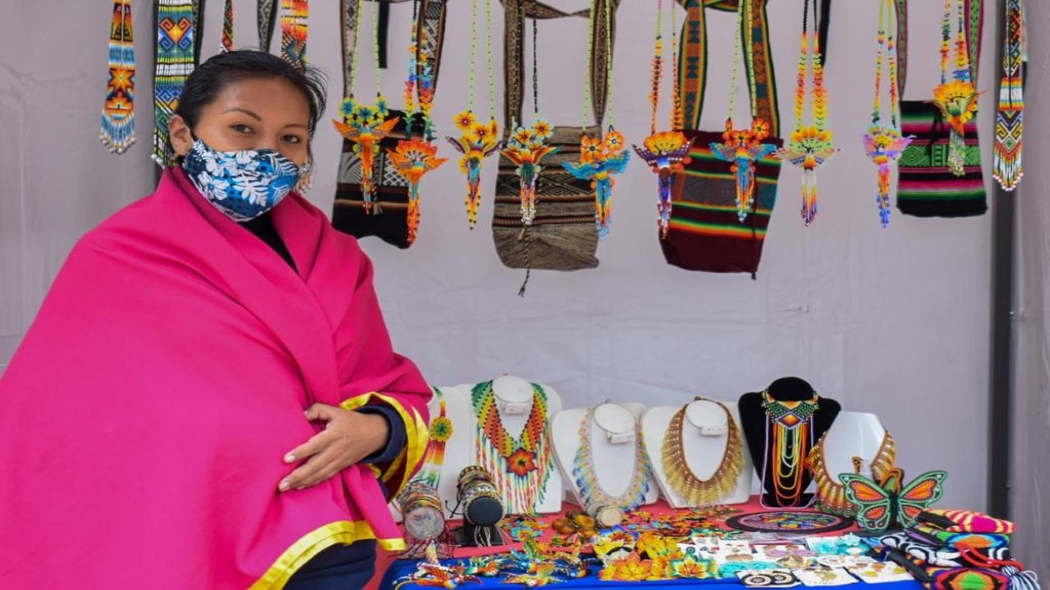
[660,0,783,277]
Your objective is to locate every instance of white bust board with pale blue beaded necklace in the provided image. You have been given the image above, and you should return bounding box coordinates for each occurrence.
[550,401,657,509]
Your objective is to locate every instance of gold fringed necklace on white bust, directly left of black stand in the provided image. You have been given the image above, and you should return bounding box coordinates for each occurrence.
[660,397,743,506]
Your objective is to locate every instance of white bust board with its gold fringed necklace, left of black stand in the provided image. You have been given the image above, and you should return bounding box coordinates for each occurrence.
[642,398,753,508]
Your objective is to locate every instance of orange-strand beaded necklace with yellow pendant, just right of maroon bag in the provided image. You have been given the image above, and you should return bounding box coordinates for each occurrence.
[778,0,839,226]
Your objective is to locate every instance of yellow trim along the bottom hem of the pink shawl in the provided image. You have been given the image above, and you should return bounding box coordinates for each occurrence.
[249,521,405,590]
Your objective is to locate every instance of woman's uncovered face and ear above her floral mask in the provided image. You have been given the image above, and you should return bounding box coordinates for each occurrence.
[169,78,310,166]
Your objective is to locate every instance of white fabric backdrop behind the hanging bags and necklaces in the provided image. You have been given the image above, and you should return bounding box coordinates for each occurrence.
[0,0,999,508]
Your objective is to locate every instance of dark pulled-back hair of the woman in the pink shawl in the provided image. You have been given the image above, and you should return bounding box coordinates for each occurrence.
[175,49,326,136]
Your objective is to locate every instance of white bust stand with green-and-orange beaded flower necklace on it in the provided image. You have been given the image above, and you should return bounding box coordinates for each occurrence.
[470,375,562,514]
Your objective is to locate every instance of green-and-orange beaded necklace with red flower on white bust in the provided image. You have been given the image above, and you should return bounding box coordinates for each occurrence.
[470,381,552,513]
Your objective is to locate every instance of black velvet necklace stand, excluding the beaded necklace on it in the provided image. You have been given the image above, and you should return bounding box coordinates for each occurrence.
[739,377,842,507]
